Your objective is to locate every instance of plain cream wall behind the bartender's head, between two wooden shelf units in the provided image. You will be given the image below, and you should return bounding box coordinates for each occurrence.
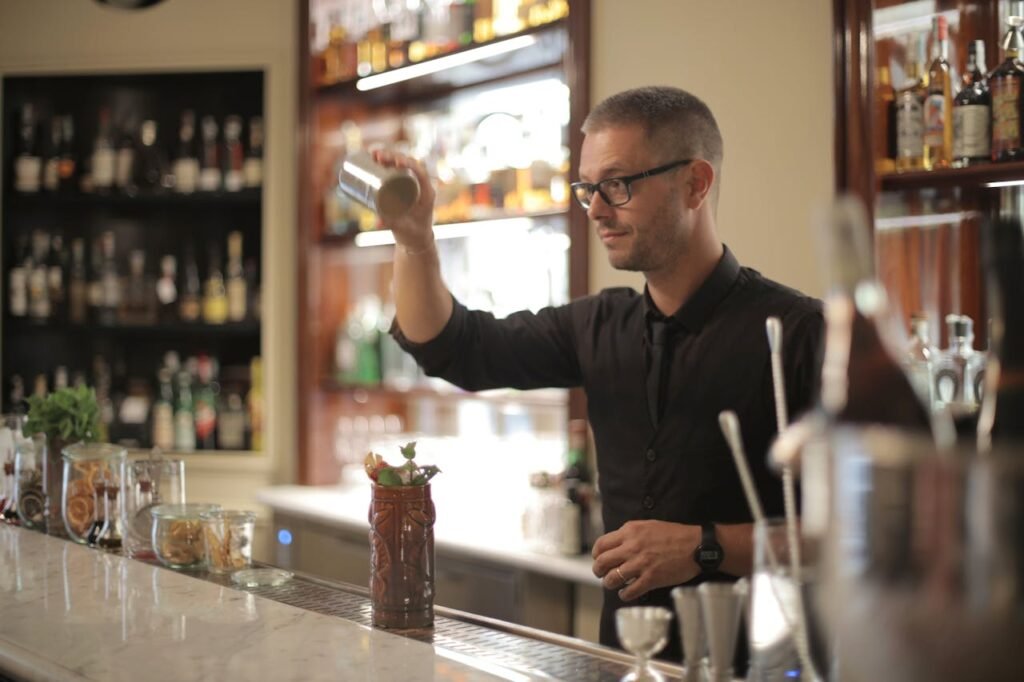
[590,0,835,295]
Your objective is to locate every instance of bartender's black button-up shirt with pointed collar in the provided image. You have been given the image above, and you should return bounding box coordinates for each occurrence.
[392,249,824,659]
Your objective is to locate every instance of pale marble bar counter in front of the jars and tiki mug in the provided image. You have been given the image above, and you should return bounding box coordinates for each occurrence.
[0,525,681,682]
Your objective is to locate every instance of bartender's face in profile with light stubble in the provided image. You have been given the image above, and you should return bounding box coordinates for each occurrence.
[580,126,690,273]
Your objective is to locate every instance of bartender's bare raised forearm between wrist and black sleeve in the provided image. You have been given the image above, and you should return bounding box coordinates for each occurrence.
[394,241,453,343]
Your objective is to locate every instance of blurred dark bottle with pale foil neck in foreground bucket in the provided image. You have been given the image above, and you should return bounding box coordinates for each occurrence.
[821,197,931,430]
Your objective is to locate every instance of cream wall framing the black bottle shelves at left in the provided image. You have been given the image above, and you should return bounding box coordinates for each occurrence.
[0,0,299,536]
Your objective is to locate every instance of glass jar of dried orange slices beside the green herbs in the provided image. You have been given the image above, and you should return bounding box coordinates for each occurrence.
[60,442,126,545]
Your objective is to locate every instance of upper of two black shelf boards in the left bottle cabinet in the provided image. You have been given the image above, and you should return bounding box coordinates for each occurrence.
[4,187,262,208]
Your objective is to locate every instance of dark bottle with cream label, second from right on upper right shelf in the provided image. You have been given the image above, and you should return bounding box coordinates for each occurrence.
[953,40,992,166]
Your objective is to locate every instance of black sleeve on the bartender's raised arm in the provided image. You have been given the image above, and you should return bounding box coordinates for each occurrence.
[391,297,586,391]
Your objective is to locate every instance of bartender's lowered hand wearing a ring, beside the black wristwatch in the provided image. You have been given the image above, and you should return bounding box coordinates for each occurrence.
[591,520,700,601]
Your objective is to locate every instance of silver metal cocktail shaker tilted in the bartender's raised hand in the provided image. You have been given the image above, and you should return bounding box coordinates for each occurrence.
[338,150,420,221]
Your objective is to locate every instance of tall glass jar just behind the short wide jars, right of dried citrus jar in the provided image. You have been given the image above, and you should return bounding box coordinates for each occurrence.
[121,458,185,560]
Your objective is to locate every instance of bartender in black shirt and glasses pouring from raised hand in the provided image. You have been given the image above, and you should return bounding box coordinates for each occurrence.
[377,87,823,660]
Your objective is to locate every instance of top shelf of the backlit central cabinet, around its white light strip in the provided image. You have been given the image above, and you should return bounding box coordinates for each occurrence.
[313,19,567,105]
